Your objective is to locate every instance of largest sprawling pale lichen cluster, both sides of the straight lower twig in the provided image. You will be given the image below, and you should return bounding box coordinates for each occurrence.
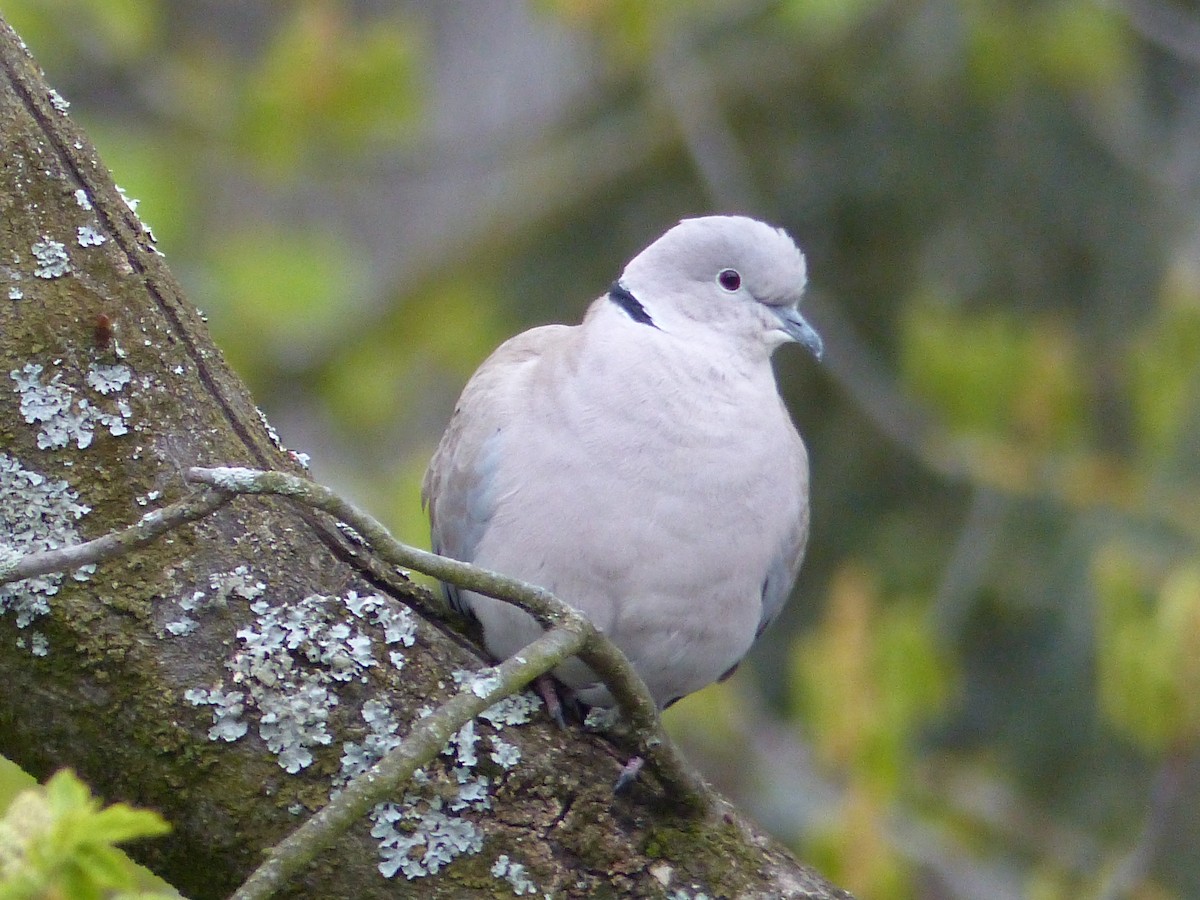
[176,580,540,893]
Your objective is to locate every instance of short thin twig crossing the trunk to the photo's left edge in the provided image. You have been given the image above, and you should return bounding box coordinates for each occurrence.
[0,488,230,584]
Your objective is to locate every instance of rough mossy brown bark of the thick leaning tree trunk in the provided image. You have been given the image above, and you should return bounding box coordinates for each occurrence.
[0,22,847,898]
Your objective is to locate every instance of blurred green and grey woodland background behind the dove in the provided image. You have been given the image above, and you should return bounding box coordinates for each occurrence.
[5,0,1200,900]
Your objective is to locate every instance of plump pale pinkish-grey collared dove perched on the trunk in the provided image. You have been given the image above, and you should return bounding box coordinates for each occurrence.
[422,216,821,707]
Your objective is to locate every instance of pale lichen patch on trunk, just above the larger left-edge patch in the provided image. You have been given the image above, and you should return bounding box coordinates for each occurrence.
[8,362,133,450]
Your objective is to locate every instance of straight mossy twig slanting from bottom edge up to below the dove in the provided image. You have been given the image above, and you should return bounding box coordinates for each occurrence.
[230,628,587,900]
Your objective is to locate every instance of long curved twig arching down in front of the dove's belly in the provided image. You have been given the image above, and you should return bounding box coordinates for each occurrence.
[185,467,713,811]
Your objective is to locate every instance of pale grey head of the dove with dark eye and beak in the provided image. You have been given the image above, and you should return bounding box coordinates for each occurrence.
[618,216,822,359]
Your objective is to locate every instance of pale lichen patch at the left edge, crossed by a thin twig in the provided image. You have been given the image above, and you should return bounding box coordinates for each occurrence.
[0,454,96,633]
